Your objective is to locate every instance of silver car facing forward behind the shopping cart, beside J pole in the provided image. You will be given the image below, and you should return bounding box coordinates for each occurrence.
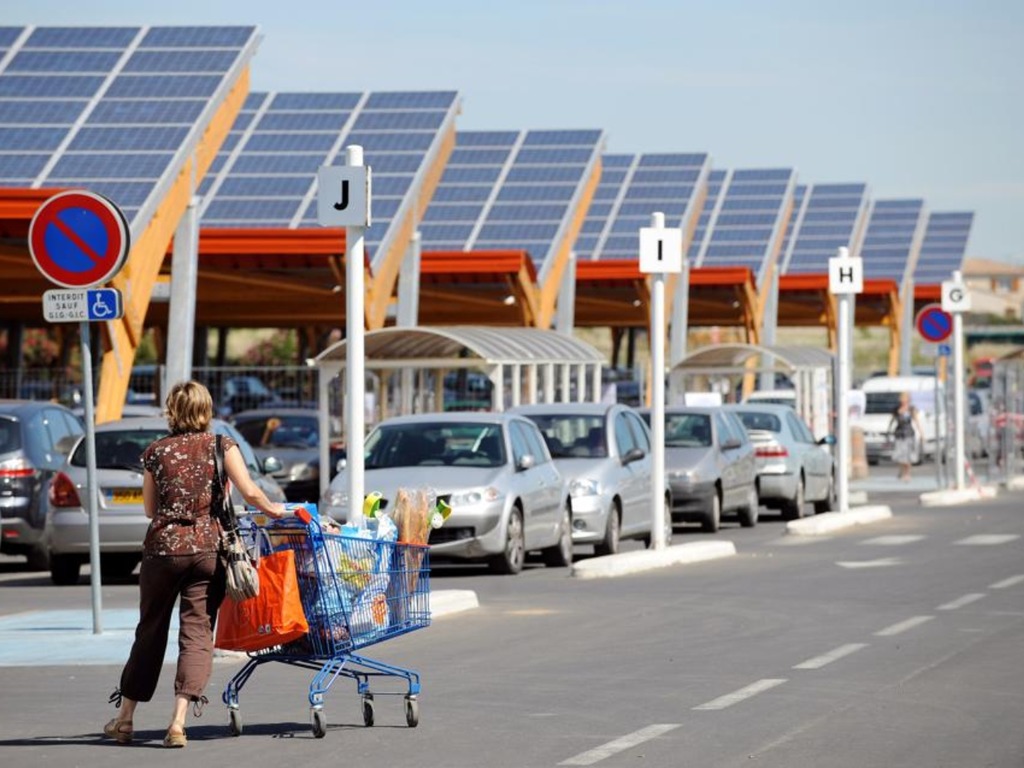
[321,413,572,573]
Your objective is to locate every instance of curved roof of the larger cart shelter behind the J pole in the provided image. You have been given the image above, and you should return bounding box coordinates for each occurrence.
[315,326,604,368]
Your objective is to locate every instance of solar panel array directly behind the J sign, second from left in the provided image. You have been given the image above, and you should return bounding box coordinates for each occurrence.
[200,91,458,256]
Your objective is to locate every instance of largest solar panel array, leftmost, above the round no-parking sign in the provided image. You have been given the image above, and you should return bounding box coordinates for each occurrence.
[0,27,256,228]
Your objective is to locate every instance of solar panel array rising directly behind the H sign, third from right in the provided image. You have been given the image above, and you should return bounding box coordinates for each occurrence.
[780,183,868,274]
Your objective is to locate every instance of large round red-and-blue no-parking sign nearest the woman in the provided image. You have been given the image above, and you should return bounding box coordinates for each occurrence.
[29,190,131,288]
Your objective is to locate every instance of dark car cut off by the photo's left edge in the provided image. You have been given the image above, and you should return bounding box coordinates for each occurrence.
[0,400,85,569]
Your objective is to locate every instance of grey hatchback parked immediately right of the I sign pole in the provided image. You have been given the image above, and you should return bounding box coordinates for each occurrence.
[641,406,760,532]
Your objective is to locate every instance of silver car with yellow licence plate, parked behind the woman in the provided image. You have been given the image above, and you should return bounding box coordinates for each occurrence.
[46,417,285,585]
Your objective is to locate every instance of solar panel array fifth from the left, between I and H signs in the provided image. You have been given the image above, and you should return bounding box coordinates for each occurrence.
[695,169,797,275]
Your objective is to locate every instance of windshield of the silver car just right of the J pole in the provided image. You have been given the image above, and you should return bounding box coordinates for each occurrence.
[366,422,505,469]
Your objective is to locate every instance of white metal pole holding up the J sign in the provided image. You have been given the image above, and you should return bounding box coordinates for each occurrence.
[345,144,367,522]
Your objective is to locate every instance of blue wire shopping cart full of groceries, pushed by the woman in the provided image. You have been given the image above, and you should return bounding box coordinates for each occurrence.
[222,510,430,738]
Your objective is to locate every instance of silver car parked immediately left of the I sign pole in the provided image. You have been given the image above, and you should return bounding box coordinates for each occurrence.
[511,402,672,555]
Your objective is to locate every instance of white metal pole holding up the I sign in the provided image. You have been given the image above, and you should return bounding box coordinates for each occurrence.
[650,207,665,550]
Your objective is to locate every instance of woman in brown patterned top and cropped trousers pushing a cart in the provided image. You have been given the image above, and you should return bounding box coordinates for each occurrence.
[103,381,286,746]
